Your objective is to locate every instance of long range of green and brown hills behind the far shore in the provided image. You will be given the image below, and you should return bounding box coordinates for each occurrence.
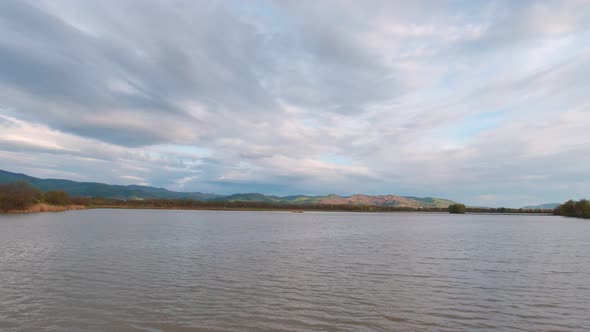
[0,170,455,208]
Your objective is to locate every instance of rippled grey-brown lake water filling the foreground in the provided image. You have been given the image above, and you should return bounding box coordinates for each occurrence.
[0,210,590,331]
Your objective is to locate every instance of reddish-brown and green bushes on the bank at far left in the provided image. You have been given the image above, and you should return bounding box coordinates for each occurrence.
[0,181,70,212]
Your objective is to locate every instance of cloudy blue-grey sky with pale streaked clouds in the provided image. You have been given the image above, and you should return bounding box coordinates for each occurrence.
[0,0,590,207]
